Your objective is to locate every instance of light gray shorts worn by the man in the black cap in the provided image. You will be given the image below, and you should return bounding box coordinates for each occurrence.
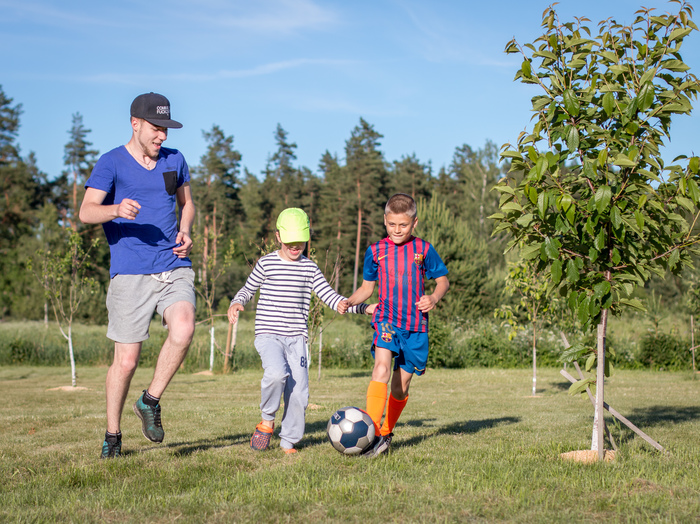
[107,267,196,344]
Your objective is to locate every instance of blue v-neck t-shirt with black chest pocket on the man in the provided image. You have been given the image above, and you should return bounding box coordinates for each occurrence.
[85,146,192,278]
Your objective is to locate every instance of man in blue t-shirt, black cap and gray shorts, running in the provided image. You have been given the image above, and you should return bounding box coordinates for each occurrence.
[80,93,195,458]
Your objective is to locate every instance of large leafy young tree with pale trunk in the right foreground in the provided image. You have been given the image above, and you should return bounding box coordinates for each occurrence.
[493,0,700,460]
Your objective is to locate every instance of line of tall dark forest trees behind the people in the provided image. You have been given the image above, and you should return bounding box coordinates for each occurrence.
[0,86,509,323]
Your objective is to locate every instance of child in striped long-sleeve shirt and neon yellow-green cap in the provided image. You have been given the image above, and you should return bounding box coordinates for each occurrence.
[228,208,374,453]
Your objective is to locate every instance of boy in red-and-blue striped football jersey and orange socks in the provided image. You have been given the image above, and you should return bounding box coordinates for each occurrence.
[348,193,450,457]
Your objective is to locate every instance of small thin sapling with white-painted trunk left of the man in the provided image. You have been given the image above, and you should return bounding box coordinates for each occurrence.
[28,230,98,387]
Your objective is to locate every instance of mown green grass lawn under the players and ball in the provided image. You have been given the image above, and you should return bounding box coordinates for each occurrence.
[0,366,700,523]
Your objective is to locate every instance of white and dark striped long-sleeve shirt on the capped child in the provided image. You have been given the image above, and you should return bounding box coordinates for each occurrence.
[231,251,367,338]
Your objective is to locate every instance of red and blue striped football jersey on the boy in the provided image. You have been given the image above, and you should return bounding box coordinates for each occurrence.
[362,237,447,332]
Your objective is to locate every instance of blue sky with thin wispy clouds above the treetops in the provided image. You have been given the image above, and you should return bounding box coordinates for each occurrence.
[0,0,700,178]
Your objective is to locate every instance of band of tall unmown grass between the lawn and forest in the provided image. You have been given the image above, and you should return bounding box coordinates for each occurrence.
[0,314,692,372]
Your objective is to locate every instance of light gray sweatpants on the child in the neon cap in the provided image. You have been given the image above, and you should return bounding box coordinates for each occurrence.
[255,335,309,449]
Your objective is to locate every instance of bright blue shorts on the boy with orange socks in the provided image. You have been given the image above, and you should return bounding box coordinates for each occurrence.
[372,322,428,375]
